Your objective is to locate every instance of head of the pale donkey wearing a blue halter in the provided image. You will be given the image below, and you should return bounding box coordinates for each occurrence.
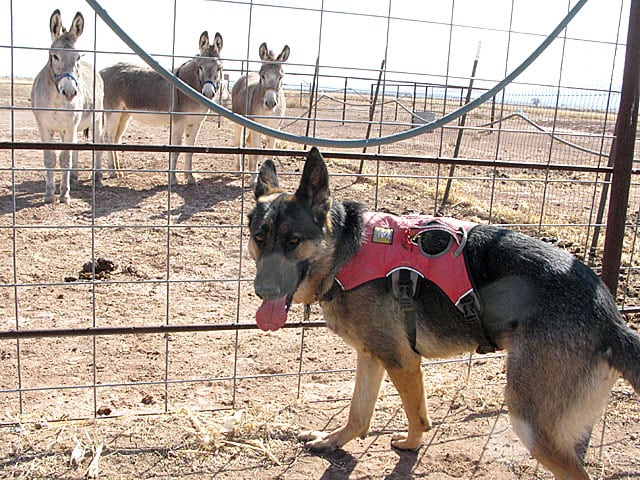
[49,9,84,101]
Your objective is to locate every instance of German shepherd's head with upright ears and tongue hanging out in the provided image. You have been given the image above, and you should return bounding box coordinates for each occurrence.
[249,147,333,330]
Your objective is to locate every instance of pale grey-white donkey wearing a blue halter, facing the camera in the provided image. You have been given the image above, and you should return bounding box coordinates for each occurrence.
[31,9,103,203]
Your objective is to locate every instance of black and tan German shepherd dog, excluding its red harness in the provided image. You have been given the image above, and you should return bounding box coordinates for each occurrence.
[249,148,640,480]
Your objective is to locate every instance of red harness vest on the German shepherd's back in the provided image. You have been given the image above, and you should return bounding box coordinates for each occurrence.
[336,212,476,306]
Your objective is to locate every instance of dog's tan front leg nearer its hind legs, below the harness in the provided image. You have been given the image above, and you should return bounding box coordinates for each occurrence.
[387,355,431,450]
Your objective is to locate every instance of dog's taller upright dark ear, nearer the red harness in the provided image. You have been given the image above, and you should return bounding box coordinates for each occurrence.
[296,147,331,224]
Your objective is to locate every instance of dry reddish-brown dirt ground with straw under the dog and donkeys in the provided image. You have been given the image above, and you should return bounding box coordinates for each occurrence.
[0,80,640,480]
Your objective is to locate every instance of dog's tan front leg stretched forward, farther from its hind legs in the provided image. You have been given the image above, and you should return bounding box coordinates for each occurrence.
[298,350,384,452]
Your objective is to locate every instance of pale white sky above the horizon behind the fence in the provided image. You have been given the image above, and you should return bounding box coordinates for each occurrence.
[0,0,630,96]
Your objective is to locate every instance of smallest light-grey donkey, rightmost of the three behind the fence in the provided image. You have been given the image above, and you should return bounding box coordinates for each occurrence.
[231,42,290,187]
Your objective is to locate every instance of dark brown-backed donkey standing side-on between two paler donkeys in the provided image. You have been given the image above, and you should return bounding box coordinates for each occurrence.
[100,31,223,185]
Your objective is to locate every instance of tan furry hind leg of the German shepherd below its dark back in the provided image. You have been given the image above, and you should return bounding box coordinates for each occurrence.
[506,347,616,480]
